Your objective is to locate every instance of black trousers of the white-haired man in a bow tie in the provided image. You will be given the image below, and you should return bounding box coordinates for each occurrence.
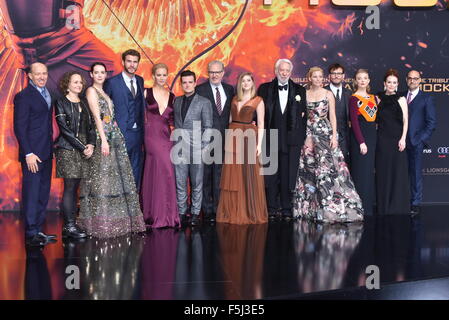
[266,152,292,214]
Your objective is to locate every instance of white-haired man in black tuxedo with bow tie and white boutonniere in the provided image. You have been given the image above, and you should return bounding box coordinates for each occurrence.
[258,59,307,219]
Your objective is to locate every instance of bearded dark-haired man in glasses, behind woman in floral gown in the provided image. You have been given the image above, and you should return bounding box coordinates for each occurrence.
[324,63,352,166]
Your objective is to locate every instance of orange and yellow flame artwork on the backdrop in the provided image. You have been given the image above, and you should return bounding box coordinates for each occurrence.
[0,0,350,210]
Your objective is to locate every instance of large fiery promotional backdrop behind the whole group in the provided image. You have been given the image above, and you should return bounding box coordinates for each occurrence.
[0,0,449,210]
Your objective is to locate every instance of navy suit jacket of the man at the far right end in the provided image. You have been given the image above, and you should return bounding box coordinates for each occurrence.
[402,90,437,146]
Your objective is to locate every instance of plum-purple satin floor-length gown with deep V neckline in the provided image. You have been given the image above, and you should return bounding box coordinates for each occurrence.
[141,89,180,228]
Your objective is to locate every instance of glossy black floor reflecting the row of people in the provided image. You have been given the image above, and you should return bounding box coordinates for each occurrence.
[0,206,449,300]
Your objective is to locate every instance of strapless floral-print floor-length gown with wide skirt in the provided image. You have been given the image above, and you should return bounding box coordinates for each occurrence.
[293,97,363,223]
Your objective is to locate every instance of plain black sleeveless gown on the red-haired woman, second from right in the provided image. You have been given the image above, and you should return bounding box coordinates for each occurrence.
[376,94,410,214]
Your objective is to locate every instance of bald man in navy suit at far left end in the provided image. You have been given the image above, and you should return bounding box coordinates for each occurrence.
[14,62,56,246]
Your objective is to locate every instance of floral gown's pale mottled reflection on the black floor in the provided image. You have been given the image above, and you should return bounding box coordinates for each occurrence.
[294,221,363,293]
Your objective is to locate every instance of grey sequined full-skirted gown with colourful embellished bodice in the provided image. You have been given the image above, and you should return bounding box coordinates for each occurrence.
[78,87,145,238]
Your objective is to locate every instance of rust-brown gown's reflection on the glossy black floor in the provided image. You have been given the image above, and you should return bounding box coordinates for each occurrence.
[217,223,268,299]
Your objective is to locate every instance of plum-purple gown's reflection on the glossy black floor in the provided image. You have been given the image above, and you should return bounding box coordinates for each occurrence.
[141,228,179,300]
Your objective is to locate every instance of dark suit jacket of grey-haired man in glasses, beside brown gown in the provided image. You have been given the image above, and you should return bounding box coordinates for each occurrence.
[195,81,235,138]
